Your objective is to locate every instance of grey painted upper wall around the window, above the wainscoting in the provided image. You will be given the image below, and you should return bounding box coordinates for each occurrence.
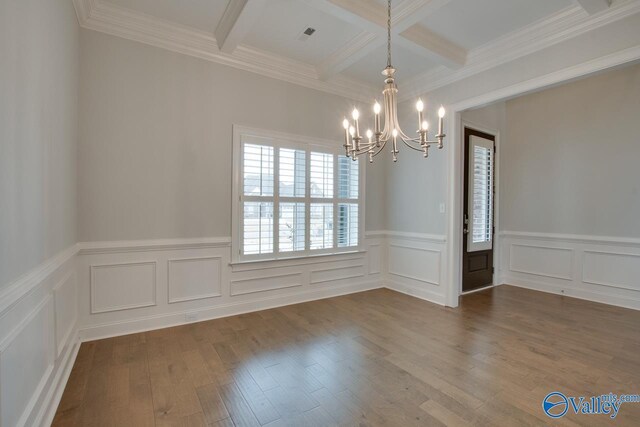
[78,30,385,241]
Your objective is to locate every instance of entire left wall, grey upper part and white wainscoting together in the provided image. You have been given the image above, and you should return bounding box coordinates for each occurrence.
[0,0,79,426]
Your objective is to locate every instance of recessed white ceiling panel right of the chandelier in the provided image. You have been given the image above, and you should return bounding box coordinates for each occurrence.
[422,0,573,49]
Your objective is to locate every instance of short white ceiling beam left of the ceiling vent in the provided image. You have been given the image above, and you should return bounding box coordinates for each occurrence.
[215,0,267,53]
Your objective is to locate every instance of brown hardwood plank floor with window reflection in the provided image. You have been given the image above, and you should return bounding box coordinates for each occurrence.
[53,286,640,427]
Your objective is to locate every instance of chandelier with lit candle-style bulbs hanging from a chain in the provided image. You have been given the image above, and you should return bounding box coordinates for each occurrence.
[342,0,445,163]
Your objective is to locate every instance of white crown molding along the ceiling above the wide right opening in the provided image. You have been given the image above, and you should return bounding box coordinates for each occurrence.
[400,0,640,101]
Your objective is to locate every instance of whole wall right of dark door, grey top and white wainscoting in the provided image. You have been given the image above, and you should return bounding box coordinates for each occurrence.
[499,65,640,309]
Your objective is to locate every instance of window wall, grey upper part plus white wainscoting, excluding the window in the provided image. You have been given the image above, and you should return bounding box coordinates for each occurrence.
[73,30,386,339]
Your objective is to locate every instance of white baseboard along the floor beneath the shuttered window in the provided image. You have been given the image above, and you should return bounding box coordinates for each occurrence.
[80,281,383,342]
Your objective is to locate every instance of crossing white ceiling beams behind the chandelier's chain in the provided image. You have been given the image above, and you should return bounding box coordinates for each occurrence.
[302,0,467,79]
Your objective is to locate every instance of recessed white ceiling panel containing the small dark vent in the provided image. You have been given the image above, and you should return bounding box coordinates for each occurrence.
[244,0,361,65]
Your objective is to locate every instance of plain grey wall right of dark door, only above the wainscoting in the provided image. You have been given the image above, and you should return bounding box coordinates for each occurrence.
[500,65,640,237]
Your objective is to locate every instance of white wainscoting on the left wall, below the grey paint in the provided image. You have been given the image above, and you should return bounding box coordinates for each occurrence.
[0,245,79,427]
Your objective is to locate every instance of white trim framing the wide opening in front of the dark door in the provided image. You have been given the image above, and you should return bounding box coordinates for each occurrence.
[444,47,640,307]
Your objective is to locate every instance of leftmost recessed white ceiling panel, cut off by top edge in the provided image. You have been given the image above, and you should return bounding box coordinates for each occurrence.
[107,0,229,33]
